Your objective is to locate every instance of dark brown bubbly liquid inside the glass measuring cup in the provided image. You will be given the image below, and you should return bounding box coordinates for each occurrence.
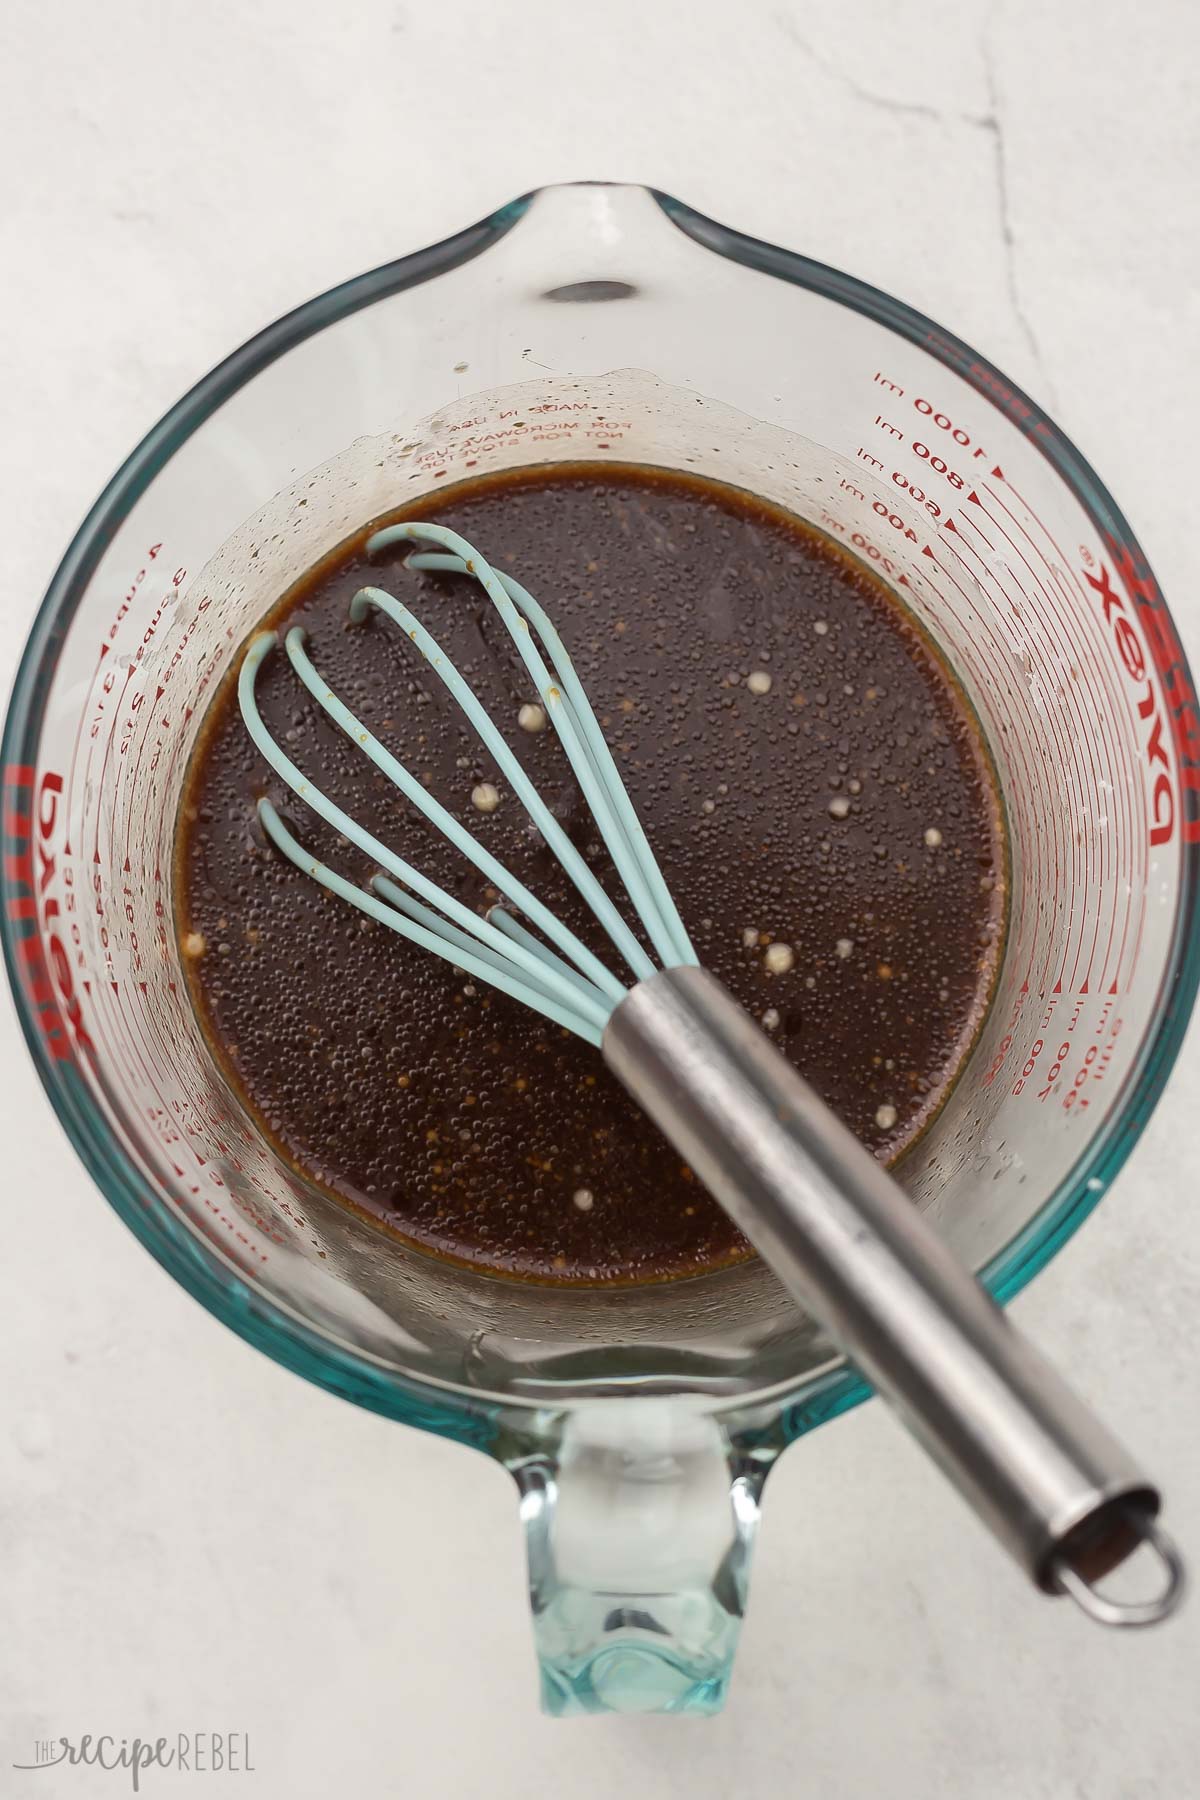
[176,466,1004,1282]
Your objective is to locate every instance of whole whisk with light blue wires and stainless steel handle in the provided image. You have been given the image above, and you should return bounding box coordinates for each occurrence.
[237,524,1182,1625]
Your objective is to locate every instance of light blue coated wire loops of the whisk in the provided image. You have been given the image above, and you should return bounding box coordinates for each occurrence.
[237,524,698,1044]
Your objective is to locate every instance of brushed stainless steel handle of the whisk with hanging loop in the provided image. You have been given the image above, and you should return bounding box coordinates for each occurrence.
[603,968,1184,1625]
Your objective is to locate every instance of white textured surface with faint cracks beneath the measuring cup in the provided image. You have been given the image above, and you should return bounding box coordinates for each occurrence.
[0,0,1200,1800]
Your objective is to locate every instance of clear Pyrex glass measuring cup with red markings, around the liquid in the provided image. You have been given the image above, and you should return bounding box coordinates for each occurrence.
[4,185,1200,1712]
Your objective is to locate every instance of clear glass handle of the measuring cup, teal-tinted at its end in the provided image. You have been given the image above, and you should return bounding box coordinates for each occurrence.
[513,1399,763,1717]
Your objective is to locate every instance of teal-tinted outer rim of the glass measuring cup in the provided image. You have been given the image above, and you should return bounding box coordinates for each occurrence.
[0,182,1200,1447]
